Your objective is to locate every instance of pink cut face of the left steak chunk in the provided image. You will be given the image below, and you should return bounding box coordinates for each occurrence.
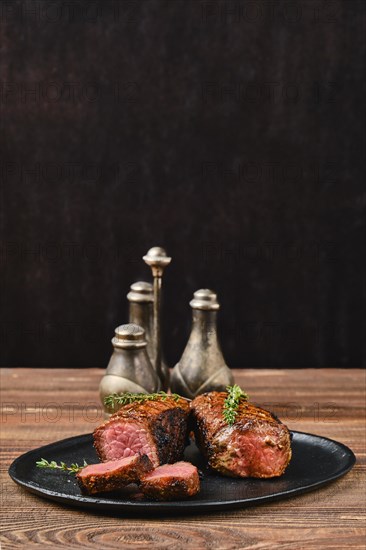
[101,420,159,465]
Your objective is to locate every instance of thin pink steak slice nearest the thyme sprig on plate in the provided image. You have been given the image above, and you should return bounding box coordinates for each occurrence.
[76,455,153,495]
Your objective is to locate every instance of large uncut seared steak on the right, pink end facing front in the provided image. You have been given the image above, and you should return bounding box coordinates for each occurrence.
[191,392,291,478]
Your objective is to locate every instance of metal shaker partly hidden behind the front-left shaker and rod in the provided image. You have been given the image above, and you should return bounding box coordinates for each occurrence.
[127,281,169,391]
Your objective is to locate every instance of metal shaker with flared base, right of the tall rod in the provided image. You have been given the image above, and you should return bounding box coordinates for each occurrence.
[171,289,234,399]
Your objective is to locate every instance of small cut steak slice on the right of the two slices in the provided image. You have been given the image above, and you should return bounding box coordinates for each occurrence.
[140,462,200,500]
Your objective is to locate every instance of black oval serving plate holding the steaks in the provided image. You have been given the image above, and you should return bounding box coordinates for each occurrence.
[9,432,356,514]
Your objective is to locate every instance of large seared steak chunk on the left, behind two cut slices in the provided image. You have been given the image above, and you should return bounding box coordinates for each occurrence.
[93,396,190,467]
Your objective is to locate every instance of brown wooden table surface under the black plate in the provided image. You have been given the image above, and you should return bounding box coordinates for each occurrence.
[0,369,366,550]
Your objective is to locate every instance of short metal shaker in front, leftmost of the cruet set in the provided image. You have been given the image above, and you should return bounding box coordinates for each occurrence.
[99,323,161,413]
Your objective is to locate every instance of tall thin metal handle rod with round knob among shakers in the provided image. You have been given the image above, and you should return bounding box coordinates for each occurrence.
[143,246,172,387]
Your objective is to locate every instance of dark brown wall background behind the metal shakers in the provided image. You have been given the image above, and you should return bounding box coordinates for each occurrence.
[0,0,365,367]
